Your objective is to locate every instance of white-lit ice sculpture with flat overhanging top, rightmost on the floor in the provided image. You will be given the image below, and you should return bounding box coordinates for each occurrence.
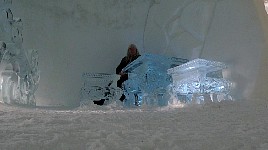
[168,59,232,103]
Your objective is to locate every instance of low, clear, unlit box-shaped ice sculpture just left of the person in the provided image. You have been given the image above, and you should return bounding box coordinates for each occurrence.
[80,73,122,106]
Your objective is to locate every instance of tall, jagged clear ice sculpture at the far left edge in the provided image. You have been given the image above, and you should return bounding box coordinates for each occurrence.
[0,0,40,106]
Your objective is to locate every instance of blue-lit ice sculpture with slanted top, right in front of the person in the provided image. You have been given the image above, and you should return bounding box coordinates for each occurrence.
[123,54,188,107]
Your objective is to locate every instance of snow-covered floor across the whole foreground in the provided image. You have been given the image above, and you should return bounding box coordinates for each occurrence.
[0,100,268,150]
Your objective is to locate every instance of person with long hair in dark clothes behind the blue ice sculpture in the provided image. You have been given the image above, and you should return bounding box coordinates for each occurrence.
[116,44,141,101]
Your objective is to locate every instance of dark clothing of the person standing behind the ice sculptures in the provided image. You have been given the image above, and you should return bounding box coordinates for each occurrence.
[116,55,140,88]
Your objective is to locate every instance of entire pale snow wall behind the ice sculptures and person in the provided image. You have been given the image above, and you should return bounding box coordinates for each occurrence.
[10,0,267,106]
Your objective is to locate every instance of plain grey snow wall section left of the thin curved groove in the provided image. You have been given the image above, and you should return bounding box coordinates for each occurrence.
[13,0,149,106]
